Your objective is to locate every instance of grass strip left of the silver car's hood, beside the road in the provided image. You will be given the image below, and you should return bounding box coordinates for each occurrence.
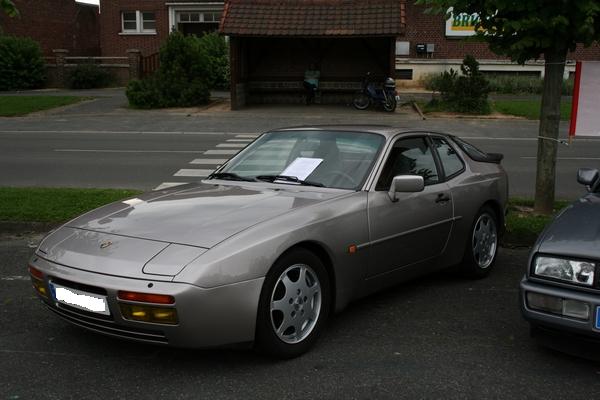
[0,187,141,223]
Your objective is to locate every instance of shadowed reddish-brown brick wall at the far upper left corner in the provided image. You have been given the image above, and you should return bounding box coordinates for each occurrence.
[0,0,100,56]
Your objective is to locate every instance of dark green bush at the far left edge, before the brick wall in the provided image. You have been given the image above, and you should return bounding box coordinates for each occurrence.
[0,35,46,90]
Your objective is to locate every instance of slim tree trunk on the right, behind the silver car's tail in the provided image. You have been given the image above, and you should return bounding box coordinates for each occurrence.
[534,49,567,215]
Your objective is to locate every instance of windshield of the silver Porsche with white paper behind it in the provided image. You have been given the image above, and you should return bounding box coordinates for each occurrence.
[214,131,384,189]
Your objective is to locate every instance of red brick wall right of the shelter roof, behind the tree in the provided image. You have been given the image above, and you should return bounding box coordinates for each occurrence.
[402,0,600,60]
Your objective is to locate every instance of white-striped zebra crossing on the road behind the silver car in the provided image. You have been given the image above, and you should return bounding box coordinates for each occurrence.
[154,134,258,190]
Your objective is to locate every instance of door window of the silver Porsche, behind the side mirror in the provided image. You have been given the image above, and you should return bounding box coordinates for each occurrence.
[375,138,439,190]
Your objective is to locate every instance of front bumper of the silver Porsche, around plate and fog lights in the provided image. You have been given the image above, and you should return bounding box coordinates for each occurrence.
[30,256,264,348]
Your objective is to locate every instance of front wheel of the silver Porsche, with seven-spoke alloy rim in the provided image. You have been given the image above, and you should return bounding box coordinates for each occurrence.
[256,248,331,358]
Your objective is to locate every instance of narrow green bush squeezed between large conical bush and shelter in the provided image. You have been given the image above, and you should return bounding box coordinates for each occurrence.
[199,32,229,89]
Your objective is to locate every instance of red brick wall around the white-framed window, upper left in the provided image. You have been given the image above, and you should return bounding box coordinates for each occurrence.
[100,0,169,57]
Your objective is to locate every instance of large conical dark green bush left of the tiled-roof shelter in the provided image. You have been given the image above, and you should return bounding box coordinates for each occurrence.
[126,32,210,108]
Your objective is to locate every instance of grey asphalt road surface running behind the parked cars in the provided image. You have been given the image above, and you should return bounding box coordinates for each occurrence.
[0,91,600,199]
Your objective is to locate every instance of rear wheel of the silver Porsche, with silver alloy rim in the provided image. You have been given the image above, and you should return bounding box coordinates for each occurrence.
[461,206,498,278]
